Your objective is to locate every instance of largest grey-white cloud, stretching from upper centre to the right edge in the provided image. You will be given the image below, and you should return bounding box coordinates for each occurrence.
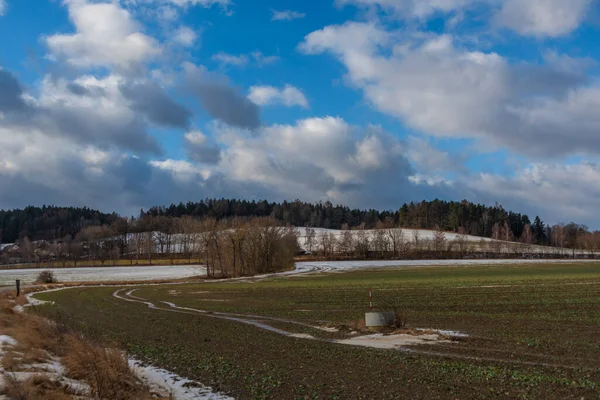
[299,22,600,156]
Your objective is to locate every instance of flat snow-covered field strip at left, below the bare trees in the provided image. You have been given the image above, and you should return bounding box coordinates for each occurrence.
[0,265,206,286]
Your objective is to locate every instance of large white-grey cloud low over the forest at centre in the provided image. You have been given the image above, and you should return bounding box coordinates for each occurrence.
[190,117,413,207]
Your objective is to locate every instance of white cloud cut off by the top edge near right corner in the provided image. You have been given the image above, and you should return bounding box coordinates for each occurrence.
[494,0,593,37]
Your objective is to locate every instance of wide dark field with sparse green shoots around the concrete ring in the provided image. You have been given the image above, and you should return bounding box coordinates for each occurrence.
[38,264,600,399]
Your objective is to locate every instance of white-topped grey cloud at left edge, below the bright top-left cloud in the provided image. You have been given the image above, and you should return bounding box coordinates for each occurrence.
[0,66,166,154]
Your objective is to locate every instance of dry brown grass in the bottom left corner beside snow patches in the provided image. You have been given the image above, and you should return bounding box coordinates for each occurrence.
[0,295,166,400]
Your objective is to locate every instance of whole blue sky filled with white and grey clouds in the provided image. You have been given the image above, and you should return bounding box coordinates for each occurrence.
[0,0,600,225]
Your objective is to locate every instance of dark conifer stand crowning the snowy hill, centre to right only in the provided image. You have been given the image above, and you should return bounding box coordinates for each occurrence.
[140,199,550,244]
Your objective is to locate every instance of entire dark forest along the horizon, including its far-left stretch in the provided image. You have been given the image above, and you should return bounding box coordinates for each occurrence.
[0,199,591,247]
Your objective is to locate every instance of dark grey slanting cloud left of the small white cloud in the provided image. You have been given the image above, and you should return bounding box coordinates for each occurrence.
[184,63,260,129]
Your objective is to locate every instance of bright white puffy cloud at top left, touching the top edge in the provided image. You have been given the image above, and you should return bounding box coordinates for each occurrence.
[46,0,161,69]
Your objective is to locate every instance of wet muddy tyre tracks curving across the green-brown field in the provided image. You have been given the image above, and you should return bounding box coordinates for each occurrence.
[113,288,594,370]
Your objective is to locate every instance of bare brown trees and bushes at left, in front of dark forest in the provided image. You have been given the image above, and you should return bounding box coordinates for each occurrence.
[0,216,298,278]
